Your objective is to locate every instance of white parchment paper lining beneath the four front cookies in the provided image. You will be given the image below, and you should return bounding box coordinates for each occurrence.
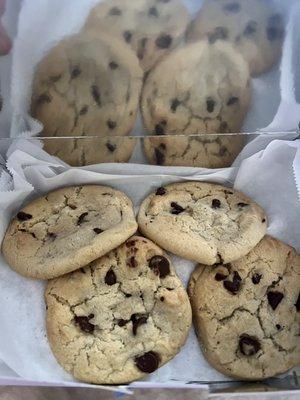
[0,139,300,384]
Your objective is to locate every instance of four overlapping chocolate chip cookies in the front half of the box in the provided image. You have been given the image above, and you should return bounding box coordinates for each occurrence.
[2,182,300,384]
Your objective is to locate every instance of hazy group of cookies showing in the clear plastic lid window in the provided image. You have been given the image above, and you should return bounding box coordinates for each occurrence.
[31,0,284,168]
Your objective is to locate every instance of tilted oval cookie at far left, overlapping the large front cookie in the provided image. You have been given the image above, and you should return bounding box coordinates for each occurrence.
[2,185,137,279]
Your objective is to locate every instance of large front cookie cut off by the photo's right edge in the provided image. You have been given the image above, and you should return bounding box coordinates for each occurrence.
[189,236,300,380]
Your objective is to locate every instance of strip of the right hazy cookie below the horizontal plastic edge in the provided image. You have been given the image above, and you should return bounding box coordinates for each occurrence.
[143,134,245,168]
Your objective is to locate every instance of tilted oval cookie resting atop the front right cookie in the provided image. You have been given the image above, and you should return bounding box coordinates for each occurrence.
[138,182,267,265]
